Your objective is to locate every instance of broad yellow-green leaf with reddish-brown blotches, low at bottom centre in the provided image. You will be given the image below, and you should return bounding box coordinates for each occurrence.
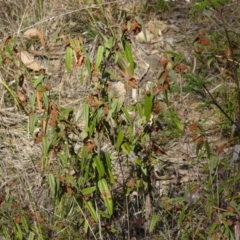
[98,179,113,215]
